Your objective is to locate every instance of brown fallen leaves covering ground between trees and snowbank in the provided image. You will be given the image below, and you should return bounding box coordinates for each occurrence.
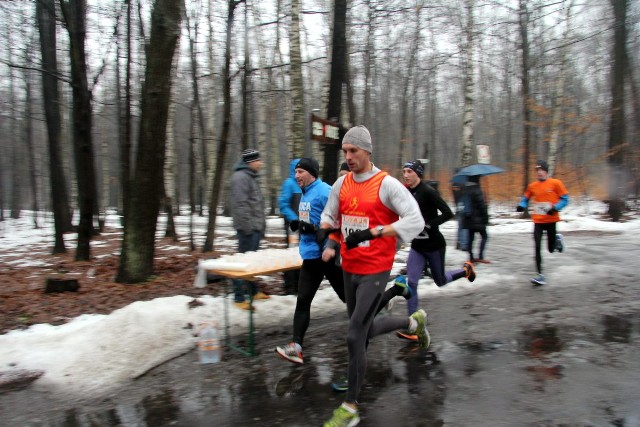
[0,229,284,334]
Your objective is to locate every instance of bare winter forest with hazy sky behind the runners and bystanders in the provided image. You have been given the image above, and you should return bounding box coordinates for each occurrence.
[0,0,640,283]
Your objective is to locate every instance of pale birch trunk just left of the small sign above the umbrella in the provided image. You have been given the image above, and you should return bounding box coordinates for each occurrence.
[460,0,475,167]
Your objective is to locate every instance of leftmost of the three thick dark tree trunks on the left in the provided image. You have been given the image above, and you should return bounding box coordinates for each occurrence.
[36,0,71,254]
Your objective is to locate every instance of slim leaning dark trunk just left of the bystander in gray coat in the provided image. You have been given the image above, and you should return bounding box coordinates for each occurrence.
[202,0,239,252]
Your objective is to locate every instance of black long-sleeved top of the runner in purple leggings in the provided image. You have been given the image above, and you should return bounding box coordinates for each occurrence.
[408,181,453,252]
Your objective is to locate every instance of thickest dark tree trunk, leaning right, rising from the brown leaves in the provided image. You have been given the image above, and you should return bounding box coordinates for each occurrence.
[116,0,184,283]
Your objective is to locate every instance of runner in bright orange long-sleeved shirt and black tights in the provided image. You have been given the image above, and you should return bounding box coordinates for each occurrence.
[516,160,569,286]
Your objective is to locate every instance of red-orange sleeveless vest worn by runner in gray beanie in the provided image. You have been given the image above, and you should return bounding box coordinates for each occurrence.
[339,171,398,274]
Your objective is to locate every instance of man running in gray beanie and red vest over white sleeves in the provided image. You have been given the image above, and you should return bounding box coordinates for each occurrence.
[316,126,430,425]
